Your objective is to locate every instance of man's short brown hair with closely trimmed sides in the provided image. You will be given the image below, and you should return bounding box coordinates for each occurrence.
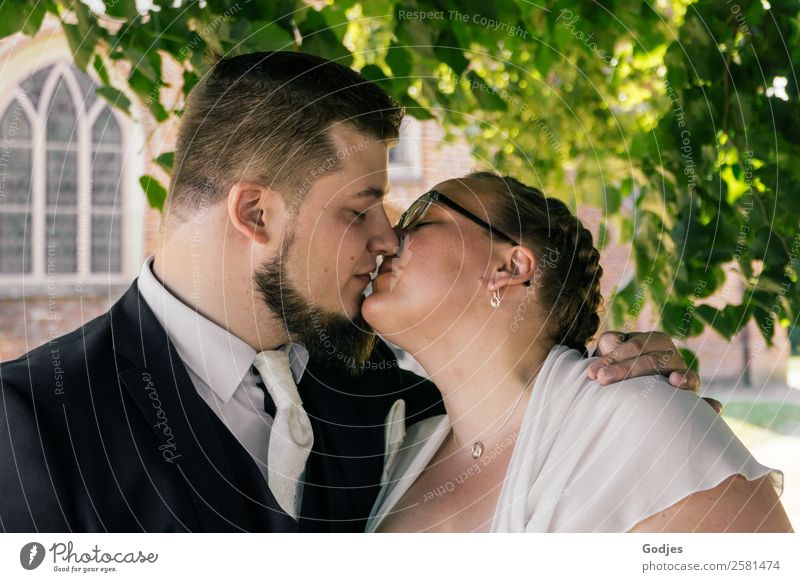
[168,52,403,219]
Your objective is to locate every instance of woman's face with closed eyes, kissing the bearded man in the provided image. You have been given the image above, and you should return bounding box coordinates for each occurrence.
[362,179,502,348]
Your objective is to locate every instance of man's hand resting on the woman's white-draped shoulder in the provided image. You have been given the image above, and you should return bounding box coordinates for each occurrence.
[587,331,722,412]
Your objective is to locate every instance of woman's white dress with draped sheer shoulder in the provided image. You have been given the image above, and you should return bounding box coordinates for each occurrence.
[366,345,783,532]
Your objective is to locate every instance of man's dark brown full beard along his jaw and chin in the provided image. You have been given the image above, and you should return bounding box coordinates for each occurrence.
[254,241,378,376]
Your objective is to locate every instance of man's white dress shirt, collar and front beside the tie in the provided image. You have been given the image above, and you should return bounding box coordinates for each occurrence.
[138,256,308,480]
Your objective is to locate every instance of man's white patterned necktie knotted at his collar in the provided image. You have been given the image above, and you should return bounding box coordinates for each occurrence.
[253,350,314,520]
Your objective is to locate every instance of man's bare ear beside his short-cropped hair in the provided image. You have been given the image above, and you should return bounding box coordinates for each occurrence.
[228,182,284,244]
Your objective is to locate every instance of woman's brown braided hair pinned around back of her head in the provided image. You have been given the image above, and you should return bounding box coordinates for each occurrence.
[467,172,603,354]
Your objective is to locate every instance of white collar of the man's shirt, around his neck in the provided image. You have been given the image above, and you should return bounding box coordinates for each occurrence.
[138,256,308,403]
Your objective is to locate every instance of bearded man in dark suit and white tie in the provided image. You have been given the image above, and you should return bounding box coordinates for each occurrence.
[0,53,697,531]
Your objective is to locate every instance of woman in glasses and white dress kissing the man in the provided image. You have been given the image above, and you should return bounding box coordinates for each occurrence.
[362,172,791,532]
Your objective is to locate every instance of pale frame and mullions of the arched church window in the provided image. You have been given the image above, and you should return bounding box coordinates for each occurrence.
[0,32,146,297]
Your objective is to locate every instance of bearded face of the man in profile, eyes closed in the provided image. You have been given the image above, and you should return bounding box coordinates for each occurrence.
[255,127,399,373]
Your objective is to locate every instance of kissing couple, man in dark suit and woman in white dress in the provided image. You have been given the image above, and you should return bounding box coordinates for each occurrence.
[0,52,791,532]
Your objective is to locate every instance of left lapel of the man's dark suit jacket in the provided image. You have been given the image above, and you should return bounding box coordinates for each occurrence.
[109,282,296,531]
